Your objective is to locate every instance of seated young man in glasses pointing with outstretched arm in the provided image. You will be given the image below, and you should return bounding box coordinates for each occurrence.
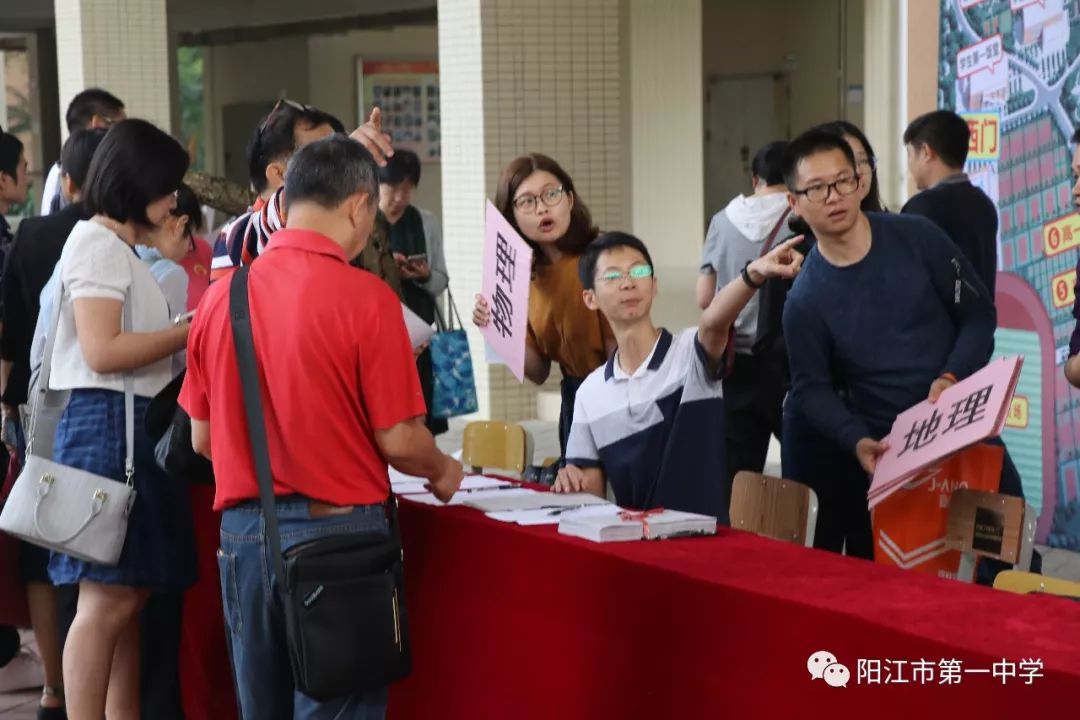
[554,232,802,522]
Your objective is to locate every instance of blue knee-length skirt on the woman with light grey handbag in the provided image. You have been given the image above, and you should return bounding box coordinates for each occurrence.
[49,390,195,590]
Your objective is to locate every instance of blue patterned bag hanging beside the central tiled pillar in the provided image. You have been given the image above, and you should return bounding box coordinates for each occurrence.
[428,288,480,419]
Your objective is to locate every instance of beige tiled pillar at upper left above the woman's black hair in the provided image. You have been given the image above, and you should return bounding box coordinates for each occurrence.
[55,0,171,137]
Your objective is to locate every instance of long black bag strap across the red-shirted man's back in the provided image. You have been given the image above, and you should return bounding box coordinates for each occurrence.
[229,266,285,588]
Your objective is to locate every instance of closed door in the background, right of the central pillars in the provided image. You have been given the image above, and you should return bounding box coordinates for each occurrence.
[705,74,791,221]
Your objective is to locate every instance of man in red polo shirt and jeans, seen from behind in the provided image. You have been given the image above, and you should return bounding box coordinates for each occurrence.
[180,136,462,720]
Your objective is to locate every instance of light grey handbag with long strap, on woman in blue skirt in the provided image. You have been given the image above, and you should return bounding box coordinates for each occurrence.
[0,274,135,565]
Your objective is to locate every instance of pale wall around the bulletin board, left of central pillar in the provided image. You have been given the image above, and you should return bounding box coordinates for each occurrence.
[308,26,443,219]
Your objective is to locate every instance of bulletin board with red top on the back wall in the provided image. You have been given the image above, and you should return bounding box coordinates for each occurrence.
[356,57,442,163]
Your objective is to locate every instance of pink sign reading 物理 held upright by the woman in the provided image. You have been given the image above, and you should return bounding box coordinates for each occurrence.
[481,202,532,381]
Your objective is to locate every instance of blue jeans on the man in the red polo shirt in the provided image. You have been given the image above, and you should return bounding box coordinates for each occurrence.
[217,498,388,720]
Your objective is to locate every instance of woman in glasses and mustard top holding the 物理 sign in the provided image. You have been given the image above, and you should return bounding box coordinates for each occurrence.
[473,153,615,464]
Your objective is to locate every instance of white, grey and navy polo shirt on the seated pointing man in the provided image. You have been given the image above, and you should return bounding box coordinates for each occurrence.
[566,328,729,524]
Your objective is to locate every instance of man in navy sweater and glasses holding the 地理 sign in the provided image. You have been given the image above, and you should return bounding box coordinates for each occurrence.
[784,131,1006,558]
